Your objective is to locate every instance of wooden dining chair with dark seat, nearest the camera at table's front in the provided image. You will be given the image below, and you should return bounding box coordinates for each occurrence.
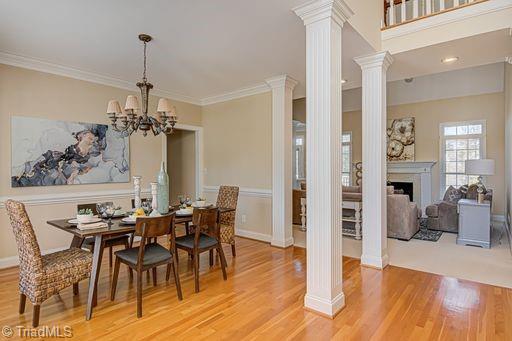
[110,213,183,317]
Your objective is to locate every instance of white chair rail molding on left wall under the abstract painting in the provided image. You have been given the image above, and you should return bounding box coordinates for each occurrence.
[0,188,151,208]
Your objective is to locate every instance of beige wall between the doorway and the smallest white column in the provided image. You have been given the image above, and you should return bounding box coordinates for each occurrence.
[202,92,272,238]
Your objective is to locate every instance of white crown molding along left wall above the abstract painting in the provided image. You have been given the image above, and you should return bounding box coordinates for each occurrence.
[0,51,201,105]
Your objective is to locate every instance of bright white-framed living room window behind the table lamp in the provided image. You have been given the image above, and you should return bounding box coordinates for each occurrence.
[439,121,485,197]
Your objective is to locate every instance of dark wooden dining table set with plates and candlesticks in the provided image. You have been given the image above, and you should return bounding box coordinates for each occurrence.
[46,206,234,320]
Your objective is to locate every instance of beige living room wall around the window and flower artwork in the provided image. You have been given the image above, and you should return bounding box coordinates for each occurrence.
[343,93,505,214]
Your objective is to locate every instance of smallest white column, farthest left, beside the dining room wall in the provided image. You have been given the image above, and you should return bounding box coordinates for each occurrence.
[266,75,297,248]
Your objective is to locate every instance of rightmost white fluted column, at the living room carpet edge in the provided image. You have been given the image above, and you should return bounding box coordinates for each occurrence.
[355,51,393,269]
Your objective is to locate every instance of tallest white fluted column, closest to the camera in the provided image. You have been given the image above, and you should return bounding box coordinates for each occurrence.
[294,0,353,317]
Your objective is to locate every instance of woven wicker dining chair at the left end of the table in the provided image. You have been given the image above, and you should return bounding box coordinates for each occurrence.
[5,200,92,327]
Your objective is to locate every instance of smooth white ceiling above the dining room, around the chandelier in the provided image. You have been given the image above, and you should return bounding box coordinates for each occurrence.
[0,0,372,102]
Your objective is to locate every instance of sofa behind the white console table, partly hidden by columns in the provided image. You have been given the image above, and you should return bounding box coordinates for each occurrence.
[293,183,421,240]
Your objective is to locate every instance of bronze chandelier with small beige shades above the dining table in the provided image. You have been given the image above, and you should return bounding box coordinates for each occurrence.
[107,34,178,136]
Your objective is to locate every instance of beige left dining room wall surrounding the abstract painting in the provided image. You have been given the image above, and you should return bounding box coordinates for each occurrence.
[0,64,201,260]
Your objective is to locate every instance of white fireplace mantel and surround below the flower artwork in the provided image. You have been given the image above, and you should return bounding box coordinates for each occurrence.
[387,161,436,215]
